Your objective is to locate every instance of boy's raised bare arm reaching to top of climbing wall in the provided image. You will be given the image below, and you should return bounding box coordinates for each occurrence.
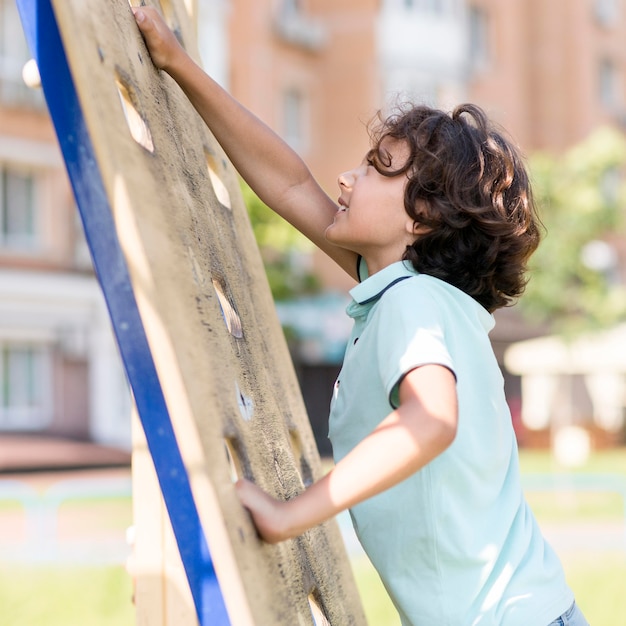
[134,7,356,277]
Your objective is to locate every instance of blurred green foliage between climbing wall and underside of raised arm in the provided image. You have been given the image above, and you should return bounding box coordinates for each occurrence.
[241,181,319,300]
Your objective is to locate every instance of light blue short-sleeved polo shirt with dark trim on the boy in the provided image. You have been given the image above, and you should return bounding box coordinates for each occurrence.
[329,262,574,626]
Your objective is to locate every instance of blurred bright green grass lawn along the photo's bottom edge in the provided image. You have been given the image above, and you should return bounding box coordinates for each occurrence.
[0,554,626,626]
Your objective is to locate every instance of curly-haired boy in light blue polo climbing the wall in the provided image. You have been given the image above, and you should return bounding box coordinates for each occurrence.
[135,8,587,626]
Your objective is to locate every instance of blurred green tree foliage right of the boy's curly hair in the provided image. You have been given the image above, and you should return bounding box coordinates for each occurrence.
[520,128,626,334]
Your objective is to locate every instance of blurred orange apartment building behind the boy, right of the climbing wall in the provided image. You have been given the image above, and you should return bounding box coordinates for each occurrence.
[221,0,626,442]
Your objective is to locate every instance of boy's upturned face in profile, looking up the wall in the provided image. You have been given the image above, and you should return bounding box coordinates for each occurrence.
[326,138,415,274]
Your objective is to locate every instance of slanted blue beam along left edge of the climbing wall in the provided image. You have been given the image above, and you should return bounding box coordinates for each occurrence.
[17,0,230,626]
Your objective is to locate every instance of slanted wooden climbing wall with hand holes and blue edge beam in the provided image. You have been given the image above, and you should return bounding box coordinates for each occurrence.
[18,0,365,626]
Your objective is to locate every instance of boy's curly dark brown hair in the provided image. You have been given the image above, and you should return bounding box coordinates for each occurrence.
[368,104,540,312]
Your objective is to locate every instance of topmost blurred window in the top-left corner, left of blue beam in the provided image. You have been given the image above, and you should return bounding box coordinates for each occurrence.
[0,0,44,108]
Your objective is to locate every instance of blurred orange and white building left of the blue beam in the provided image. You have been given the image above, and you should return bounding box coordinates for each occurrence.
[0,0,130,447]
